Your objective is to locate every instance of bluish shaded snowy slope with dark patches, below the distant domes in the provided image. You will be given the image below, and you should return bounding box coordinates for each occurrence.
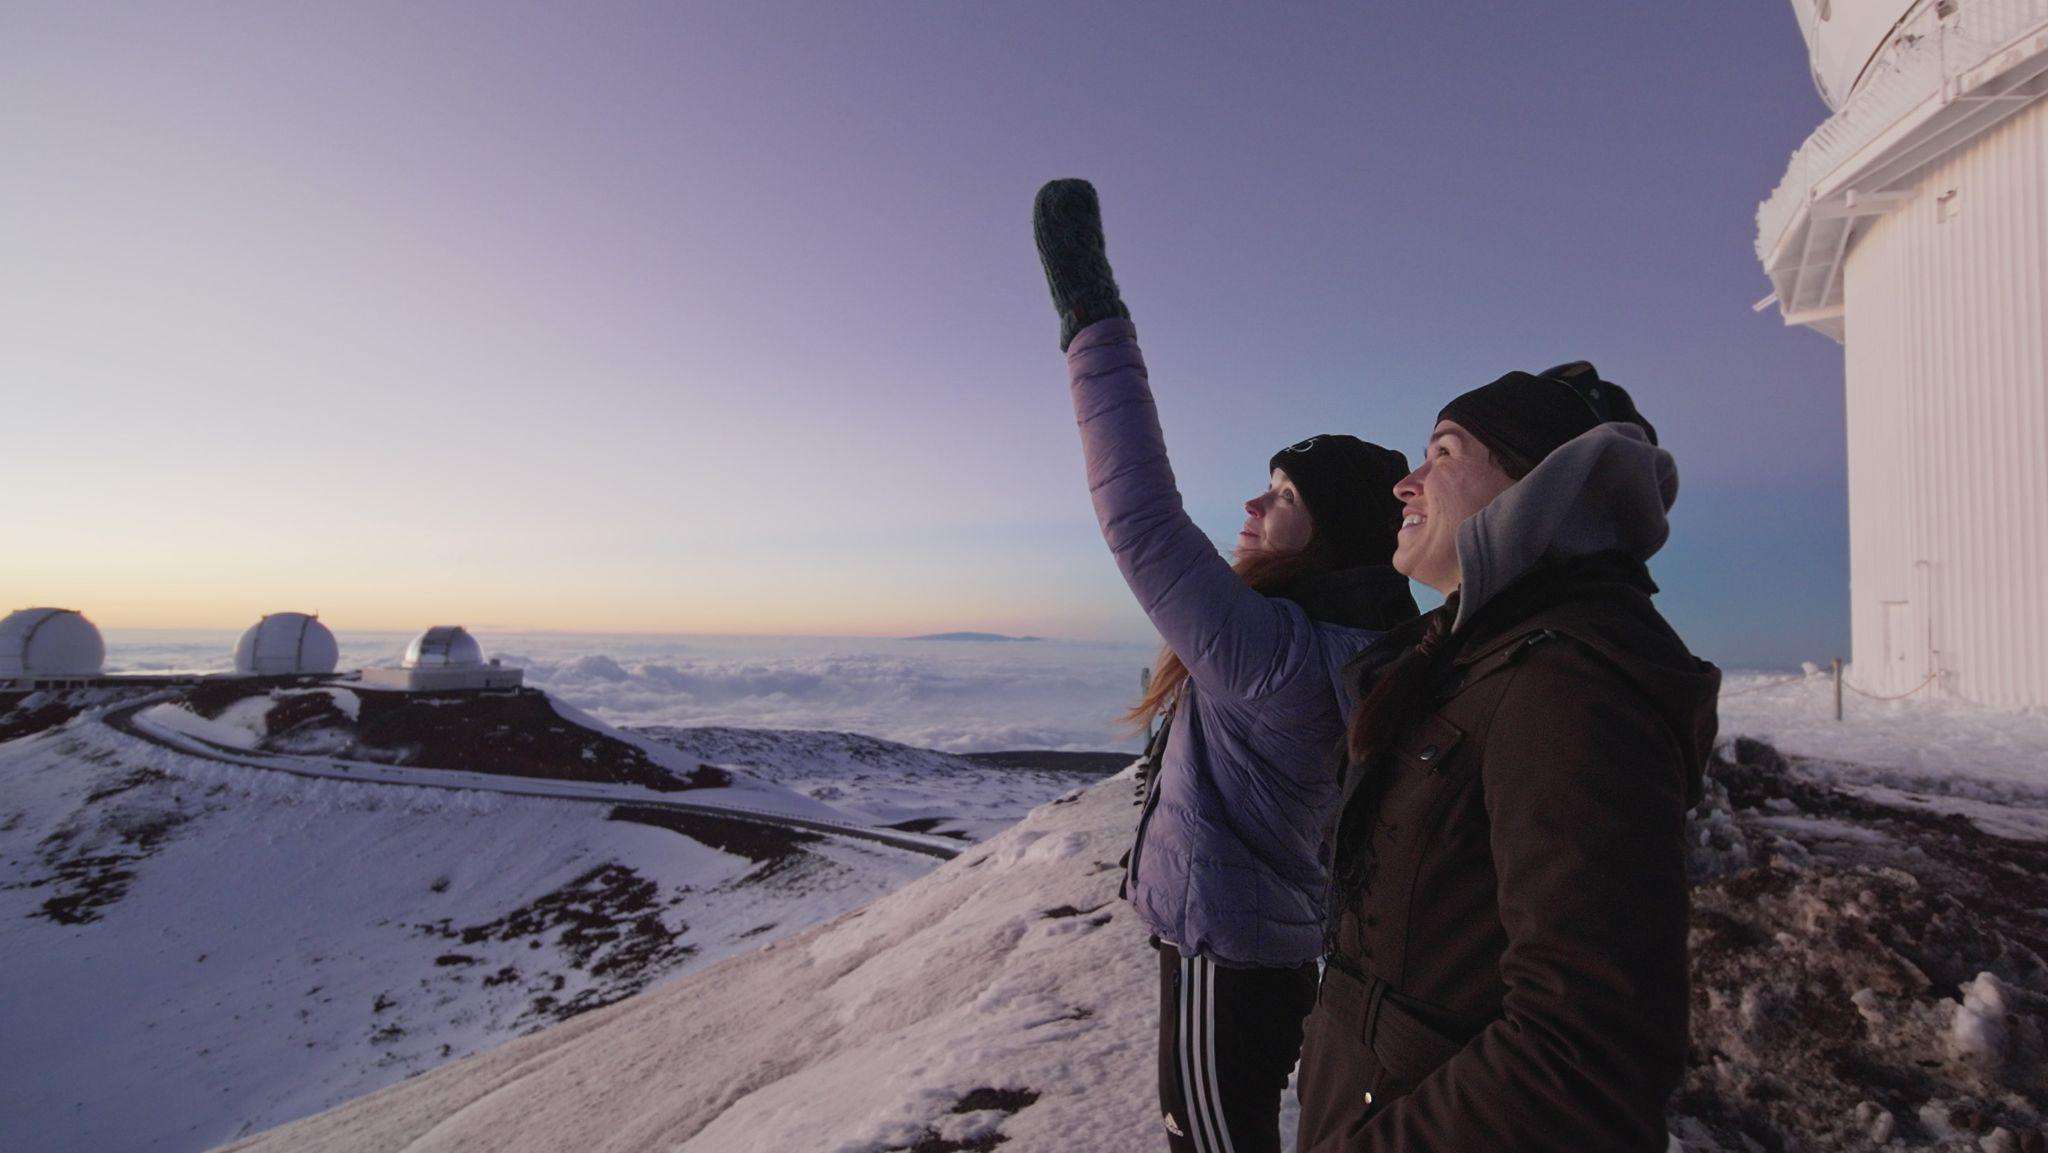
[0,694,1081,1151]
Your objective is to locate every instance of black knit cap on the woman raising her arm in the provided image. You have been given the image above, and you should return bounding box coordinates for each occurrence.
[1266,432,1409,569]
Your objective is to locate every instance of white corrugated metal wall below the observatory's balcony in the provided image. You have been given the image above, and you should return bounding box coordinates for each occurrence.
[1843,102,2048,707]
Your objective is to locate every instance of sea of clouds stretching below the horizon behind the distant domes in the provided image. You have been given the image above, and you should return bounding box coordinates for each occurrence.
[106,629,1153,752]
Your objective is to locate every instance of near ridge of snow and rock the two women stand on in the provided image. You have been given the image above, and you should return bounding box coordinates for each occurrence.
[211,729,2048,1153]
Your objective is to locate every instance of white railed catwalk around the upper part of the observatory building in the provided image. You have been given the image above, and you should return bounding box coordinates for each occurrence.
[1757,0,2048,264]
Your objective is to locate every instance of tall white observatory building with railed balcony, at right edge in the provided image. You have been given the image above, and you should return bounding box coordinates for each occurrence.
[1757,0,2048,707]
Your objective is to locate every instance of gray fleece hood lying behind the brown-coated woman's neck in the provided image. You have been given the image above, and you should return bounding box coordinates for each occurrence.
[1452,420,1677,631]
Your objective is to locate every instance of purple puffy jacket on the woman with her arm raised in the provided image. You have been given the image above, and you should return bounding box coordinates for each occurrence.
[1067,319,1415,967]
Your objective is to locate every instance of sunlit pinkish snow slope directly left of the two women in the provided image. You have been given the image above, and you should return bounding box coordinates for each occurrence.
[218,765,1159,1153]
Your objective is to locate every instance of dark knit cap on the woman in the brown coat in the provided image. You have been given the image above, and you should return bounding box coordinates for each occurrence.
[1436,360,1657,479]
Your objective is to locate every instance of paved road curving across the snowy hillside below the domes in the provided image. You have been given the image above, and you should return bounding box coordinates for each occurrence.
[100,696,971,860]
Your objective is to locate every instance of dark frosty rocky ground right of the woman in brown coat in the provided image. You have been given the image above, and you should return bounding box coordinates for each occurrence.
[1671,741,2048,1153]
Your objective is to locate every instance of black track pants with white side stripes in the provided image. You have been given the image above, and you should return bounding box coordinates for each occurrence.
[1159,944,1315,1153]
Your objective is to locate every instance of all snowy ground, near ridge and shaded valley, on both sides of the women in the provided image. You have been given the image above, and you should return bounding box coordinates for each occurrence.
[0,674,2048,1153]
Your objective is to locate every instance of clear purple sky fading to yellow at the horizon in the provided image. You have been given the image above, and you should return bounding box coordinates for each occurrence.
[0,2,1847,666]
